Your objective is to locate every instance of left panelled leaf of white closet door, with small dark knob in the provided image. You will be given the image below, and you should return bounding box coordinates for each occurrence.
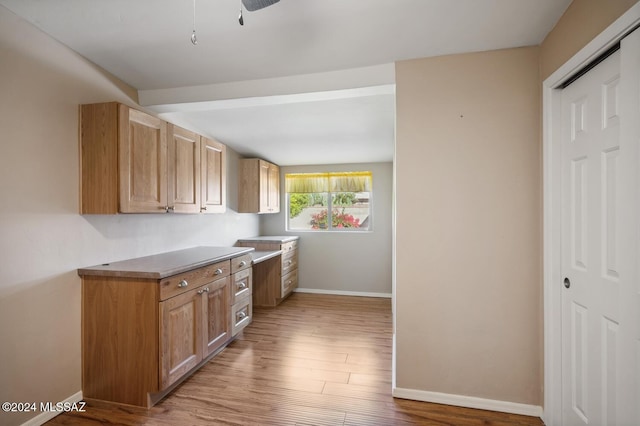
[562,48,620,425]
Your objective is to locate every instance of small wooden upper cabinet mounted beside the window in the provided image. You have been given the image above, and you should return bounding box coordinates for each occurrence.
[238,158,280,213]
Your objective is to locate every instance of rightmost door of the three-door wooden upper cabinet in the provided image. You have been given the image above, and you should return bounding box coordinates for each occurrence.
[201,137,227,213]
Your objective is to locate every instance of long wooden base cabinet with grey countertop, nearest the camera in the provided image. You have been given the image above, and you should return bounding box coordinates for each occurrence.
[78,248,252,407]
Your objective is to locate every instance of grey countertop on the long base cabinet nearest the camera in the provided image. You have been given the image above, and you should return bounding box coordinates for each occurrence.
[78,246,254,279]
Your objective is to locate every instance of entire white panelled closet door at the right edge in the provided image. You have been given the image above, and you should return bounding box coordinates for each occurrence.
[558,31,640,426]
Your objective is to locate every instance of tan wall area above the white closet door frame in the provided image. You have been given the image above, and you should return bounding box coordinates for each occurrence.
[540,0,638,80]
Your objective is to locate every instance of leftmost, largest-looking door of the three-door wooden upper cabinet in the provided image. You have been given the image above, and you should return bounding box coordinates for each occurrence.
[118,105,167,213]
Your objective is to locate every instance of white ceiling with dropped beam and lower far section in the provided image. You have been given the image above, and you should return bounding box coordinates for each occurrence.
[0,0,571,165]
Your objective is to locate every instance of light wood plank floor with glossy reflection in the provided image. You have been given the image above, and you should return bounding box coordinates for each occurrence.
[48,293,542,426]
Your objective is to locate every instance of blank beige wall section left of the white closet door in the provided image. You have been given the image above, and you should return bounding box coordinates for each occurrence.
[396,47,542,406]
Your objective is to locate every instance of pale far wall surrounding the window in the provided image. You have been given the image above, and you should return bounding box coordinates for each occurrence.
[260,163,393,295]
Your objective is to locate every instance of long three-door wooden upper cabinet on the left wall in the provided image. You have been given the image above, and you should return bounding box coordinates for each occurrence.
[80,102,226,214]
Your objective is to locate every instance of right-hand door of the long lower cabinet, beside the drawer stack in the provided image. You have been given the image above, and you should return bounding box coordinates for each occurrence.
[203,276,231,357]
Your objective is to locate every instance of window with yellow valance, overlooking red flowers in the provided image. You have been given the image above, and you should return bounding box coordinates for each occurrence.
[285,172,373,232]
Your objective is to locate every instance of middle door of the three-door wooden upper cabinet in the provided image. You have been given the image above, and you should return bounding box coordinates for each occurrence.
[167,124,201,213]
